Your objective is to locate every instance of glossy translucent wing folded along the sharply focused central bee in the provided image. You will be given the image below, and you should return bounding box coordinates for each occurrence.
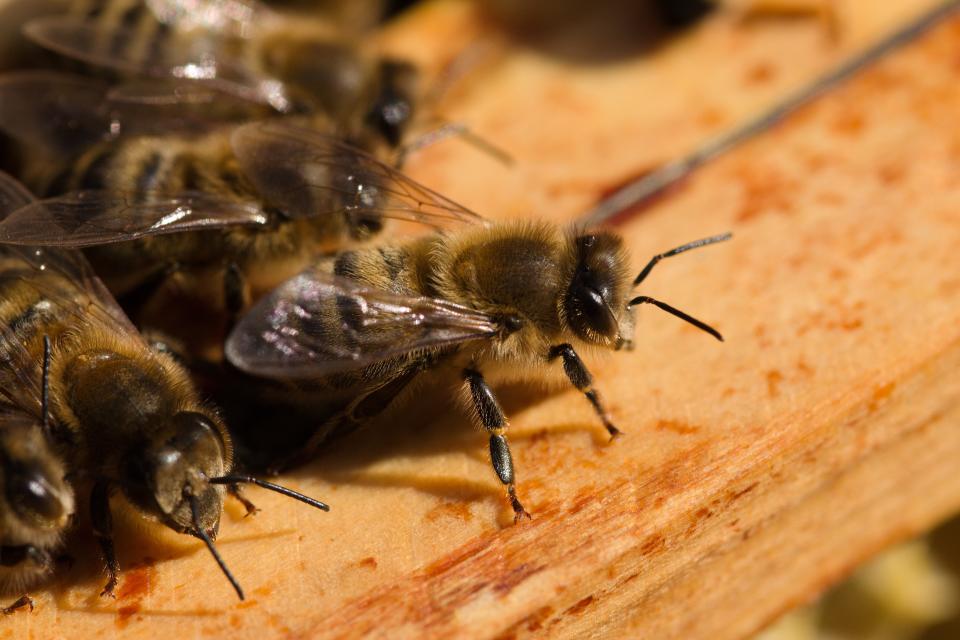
[226,268,500,379]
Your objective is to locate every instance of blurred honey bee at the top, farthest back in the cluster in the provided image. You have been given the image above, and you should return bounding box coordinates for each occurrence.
[16,0,417,146]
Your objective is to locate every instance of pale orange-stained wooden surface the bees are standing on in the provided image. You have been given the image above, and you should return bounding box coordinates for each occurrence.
[0,2,960,640]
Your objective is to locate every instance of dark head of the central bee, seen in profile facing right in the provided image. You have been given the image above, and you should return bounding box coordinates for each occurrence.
[562,232,633,348]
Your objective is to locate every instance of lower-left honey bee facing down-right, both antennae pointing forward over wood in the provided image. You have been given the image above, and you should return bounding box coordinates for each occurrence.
[0,170,328,599]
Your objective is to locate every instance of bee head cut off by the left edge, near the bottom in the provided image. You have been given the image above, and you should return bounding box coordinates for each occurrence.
[0,421,74,533]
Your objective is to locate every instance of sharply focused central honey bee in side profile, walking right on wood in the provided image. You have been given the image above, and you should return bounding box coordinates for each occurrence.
[219,126,730,519]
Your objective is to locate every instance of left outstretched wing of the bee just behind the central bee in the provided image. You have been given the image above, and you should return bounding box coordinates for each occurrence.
[0,191,268,247]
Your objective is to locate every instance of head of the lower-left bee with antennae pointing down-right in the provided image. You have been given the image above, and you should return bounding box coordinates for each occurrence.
[125,411,228,538]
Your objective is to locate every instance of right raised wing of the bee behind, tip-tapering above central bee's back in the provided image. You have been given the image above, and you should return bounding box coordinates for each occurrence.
[232,122,486,228]
